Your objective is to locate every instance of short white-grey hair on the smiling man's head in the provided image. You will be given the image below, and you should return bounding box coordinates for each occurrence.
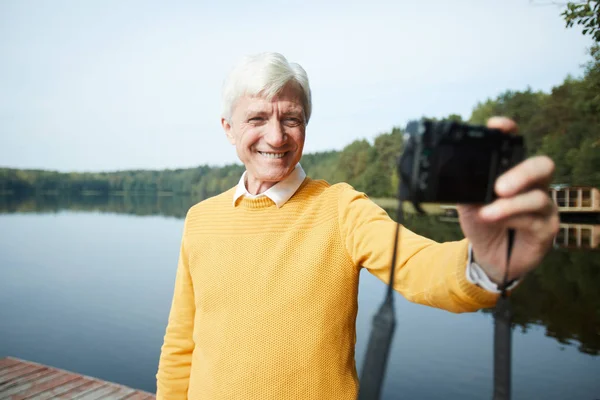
[221,53,312,123]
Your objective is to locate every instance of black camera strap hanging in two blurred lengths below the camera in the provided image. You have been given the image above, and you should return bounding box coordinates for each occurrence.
[358,200,515,400]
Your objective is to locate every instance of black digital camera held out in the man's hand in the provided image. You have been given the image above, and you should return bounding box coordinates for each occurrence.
[398,119,525,211]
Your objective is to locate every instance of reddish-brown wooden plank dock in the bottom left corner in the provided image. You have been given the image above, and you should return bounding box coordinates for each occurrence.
[0,357,155,400]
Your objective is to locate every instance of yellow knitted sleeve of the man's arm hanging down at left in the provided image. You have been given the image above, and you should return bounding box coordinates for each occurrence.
[156,220,196,400]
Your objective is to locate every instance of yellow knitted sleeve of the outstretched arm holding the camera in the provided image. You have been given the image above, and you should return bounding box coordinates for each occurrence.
[339,186,498,312]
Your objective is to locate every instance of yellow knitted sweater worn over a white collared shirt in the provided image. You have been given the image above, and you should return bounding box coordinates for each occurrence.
[157,178,497,400]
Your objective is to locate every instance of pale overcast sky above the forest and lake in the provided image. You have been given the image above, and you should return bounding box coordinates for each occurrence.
[0,0,592,171]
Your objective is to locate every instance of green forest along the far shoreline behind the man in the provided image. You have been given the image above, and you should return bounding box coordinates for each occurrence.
[0,44,600,199]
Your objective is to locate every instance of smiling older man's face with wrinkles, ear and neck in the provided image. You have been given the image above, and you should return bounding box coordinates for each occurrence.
[221,84,306,194]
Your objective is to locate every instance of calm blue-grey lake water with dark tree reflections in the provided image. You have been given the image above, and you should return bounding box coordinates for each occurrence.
[0,197,600,400]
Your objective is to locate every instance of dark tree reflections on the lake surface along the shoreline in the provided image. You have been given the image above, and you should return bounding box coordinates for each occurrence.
[0,196,600,355]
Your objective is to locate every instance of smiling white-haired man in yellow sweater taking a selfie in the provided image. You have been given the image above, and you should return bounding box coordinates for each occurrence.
[157,53,558,400]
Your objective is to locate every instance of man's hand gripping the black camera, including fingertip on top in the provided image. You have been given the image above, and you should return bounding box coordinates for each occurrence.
[458,117,560,284]
